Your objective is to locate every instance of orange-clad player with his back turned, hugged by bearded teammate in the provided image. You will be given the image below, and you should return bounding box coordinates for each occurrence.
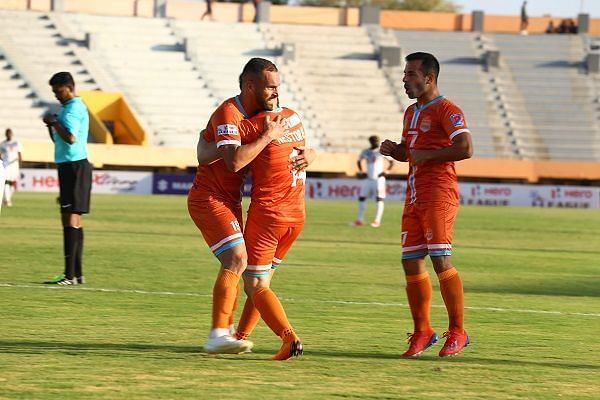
[200,108,315,360]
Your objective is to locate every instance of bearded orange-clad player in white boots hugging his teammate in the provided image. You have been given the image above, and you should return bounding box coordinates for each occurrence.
[188,58,285,353]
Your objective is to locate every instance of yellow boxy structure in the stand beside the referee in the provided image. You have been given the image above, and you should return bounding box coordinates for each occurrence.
[79,91,146,145]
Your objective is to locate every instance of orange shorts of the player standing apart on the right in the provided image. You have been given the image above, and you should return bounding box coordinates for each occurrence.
[402,201,458,260]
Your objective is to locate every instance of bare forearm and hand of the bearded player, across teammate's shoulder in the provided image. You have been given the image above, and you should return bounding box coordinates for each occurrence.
[217,115,286,172]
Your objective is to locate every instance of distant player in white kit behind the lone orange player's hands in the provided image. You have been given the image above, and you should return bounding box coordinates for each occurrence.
[354,136,393,228]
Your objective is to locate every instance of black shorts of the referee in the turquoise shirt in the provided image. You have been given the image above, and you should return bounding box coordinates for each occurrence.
[57,159,92,214]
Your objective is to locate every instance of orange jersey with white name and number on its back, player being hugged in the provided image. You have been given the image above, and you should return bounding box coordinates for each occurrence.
[240,108,306,226]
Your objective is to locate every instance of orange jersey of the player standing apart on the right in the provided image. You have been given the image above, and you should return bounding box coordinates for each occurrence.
[402,96,469,204]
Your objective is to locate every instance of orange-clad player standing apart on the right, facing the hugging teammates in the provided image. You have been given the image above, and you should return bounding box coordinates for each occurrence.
[381,53,473,357]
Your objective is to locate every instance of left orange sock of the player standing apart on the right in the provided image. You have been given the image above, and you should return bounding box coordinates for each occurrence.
[406,272,432,332]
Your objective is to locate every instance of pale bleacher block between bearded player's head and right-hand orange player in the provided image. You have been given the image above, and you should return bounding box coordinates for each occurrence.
[261,24,402,152]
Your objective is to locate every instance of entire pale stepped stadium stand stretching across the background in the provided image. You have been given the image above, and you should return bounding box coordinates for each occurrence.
[0,4,600,165]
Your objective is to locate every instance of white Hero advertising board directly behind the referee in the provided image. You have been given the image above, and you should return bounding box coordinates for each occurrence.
[19,168,152,194]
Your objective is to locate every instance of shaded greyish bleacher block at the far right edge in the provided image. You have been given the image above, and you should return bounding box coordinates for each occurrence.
[493,34,600,160]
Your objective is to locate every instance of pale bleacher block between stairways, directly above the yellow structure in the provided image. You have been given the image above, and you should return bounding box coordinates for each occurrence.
[64,14,217,148]
